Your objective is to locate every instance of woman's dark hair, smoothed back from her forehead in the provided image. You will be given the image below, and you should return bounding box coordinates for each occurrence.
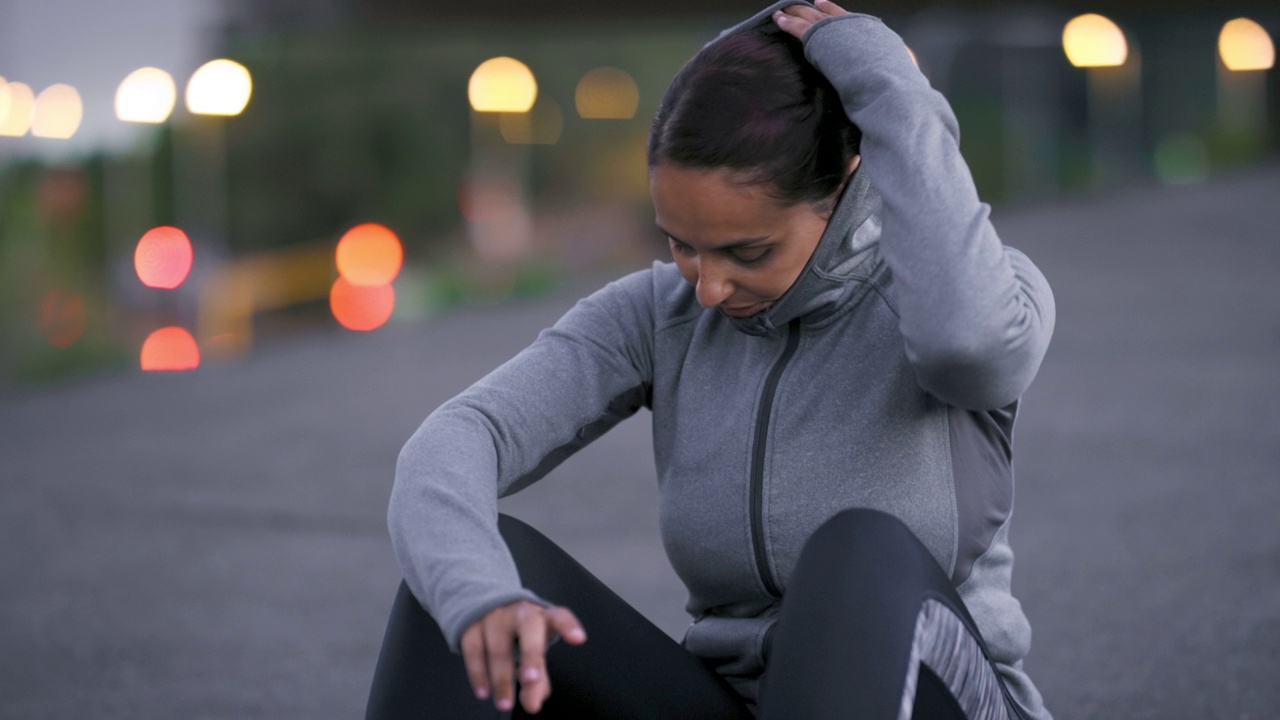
[649,29,861,205]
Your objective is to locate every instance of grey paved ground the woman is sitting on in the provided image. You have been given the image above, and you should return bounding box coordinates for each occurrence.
[0,168,1280,720]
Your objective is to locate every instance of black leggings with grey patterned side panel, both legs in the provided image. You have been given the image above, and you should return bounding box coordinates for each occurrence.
[366,510,1018,720]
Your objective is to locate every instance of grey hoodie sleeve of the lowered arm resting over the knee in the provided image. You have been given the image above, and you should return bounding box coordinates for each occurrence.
[388,266,653,652]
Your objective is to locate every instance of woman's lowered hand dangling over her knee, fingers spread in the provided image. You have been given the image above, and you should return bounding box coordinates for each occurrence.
[462,600,586,714]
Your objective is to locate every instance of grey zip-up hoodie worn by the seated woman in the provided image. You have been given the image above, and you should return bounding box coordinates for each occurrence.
[388,1,1053,719]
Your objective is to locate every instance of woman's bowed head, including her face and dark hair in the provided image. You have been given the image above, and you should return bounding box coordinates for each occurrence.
[649,29,861,316]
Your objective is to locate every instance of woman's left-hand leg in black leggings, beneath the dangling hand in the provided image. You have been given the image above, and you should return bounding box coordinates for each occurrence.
[367,515,751,720]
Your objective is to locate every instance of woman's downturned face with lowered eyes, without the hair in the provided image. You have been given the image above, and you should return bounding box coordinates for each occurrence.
[649,159,856,318]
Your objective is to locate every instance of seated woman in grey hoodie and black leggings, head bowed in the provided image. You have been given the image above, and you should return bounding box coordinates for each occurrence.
[369,0,1053,719]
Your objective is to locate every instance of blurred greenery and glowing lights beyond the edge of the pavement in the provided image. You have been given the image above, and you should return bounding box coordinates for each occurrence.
[0,0,1280,393]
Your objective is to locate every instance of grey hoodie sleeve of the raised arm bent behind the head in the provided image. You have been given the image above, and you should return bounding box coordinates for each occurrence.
[804,13,1053,410]
